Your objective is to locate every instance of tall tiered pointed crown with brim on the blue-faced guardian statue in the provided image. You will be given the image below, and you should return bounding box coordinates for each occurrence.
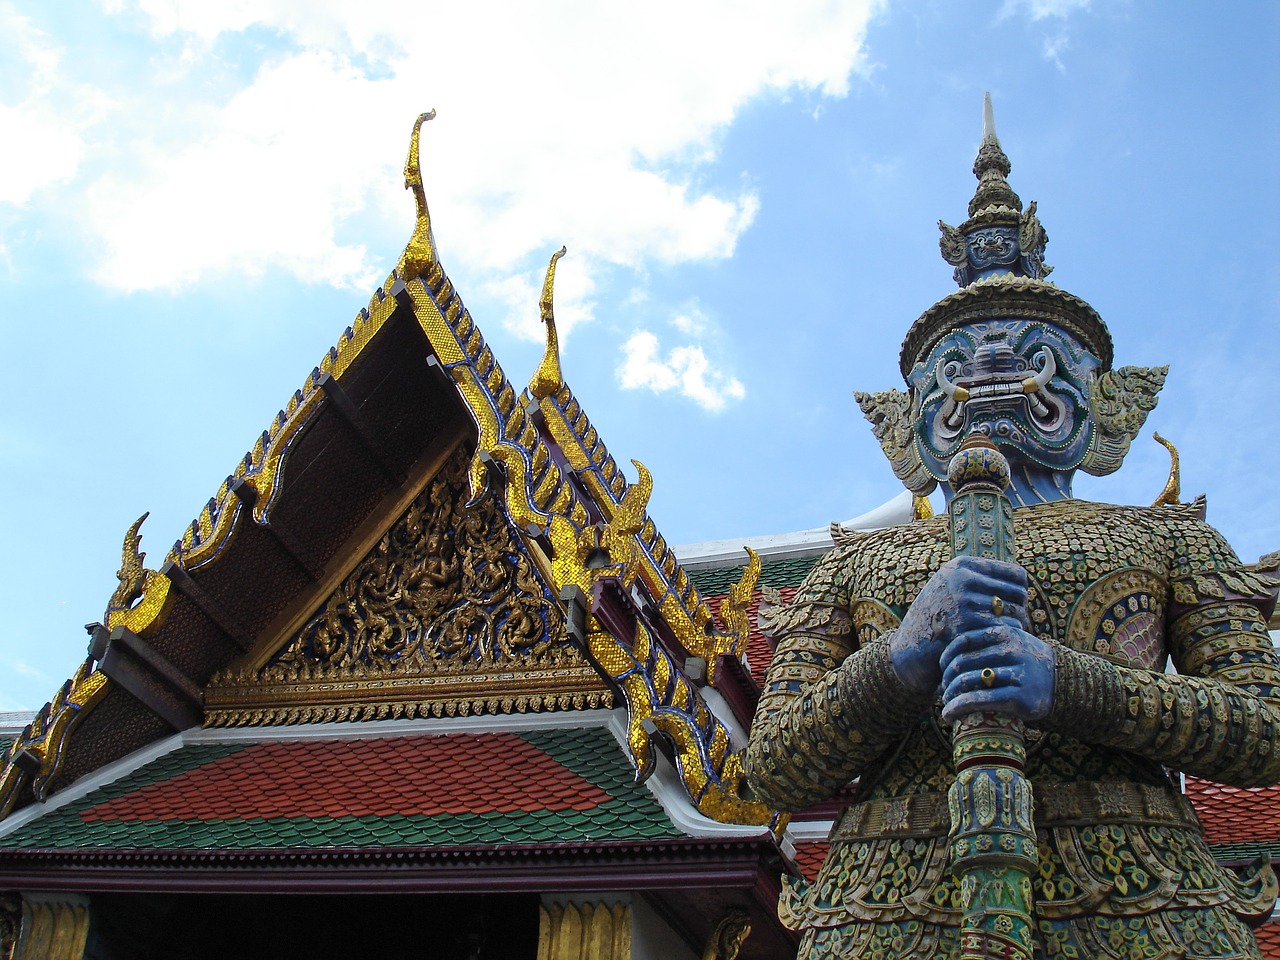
[899,93,1112,378]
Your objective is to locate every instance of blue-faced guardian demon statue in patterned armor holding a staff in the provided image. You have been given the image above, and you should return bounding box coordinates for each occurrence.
[748,101,1280,960]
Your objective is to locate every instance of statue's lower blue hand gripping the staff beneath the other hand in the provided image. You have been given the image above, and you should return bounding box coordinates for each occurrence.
[940,564,1057,721]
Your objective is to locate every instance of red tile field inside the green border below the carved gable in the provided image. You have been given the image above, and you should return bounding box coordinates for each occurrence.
[79,733,611,823]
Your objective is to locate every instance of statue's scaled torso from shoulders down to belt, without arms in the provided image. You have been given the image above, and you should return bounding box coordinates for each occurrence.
[837,500,1216,799]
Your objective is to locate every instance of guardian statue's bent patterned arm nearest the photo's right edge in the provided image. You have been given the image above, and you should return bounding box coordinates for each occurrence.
[1044,527,1280,786]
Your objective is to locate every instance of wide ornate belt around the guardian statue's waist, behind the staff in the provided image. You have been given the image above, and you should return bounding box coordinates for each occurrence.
[831,782,1201,844]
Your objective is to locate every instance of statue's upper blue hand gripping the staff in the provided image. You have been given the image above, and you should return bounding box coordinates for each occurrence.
[890,557,1034,694]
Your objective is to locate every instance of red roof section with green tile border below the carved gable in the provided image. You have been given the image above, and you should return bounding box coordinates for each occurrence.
[0,724,684,856]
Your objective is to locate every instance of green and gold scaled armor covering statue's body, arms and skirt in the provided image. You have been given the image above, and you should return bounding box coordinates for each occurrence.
[749,500,1280,960]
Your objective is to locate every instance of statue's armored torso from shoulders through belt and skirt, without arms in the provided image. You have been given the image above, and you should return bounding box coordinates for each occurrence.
[783,500,1269,947]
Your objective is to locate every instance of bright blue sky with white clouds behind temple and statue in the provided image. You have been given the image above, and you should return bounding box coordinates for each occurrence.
[0,0,1280,709]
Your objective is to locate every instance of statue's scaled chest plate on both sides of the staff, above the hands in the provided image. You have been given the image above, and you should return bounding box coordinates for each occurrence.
[851,509,1172,669]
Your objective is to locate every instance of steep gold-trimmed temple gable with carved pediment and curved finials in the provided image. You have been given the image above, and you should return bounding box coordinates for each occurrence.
[0,114,781,849]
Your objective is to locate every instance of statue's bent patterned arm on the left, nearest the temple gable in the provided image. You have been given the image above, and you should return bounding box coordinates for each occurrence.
[746,552,932,810]
